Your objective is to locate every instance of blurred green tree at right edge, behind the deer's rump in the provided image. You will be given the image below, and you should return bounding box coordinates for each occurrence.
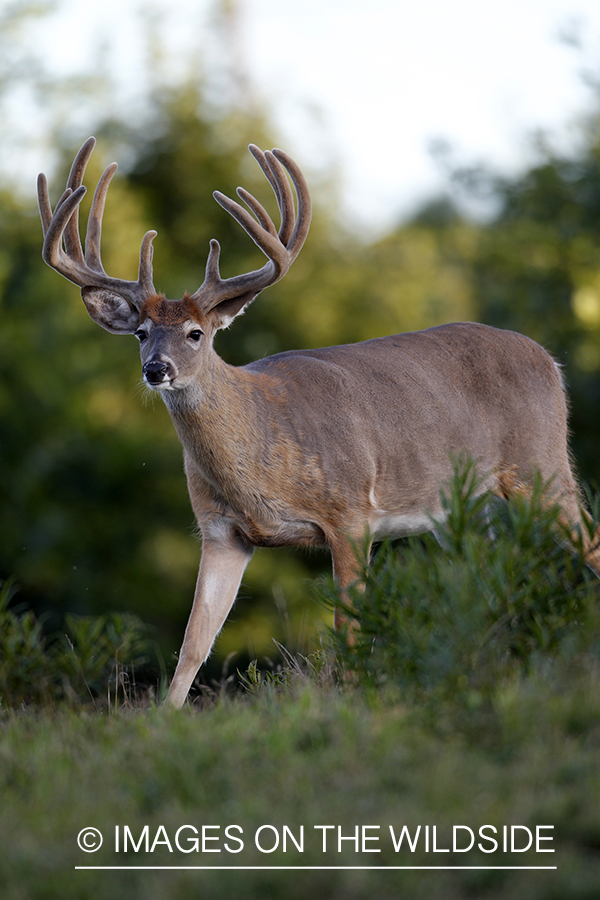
[450,115,600,483]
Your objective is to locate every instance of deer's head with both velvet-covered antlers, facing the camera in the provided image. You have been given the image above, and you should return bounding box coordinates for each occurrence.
[38,137,311,391]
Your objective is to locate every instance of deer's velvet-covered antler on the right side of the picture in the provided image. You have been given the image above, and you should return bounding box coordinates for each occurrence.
[192,144,311,312]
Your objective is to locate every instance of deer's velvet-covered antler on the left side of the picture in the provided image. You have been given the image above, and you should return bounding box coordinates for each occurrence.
[38,137,156,308]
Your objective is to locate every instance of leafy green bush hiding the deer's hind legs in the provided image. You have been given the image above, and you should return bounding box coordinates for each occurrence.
[326,465,600,706]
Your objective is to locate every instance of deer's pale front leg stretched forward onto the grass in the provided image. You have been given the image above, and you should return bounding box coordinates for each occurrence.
[165,539,252,709]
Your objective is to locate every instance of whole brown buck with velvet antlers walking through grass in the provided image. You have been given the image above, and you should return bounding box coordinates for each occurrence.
[38,137,600,707]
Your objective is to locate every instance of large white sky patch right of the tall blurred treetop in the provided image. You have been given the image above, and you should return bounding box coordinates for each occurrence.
[243,0,600,232]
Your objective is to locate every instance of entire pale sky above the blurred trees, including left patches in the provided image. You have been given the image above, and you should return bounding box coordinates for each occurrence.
[9,0,600,232]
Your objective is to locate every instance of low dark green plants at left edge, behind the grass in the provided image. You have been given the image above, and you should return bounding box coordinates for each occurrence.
[0,581,148,709]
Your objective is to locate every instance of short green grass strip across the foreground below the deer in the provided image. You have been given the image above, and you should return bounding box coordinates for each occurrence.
[0,666,600,900]
